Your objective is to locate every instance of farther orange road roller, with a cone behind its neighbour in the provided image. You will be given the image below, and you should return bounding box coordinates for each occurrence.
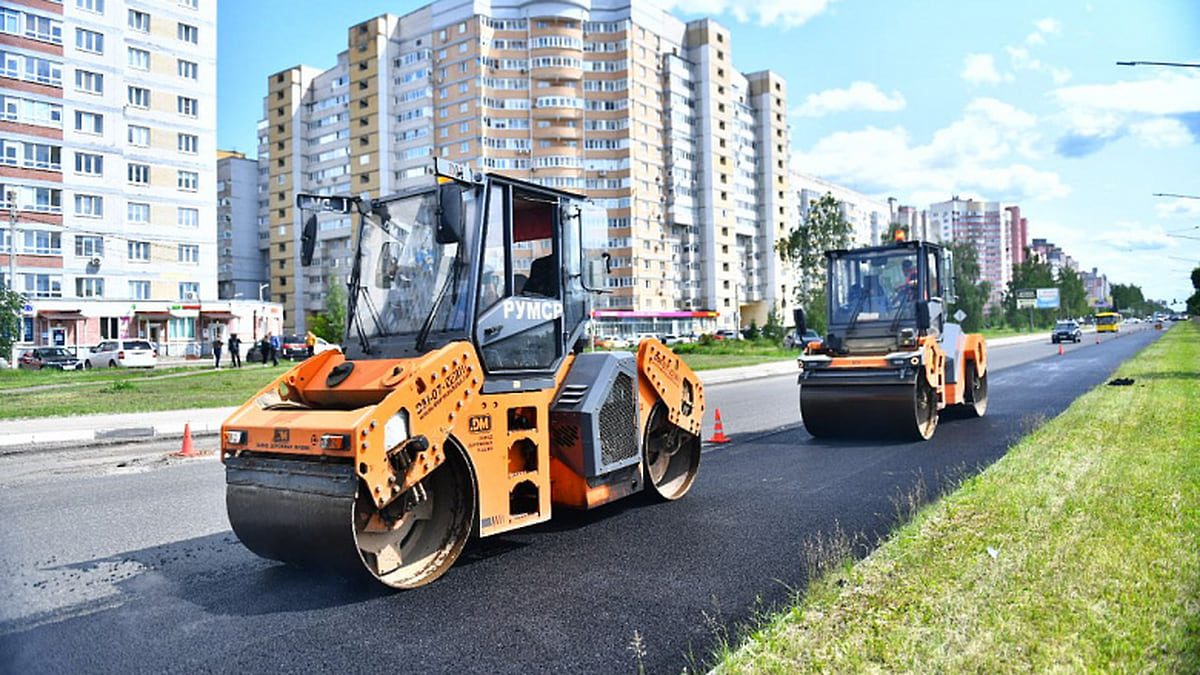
[796,240,988,441]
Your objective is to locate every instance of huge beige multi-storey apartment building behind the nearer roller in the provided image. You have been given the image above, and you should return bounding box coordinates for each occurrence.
[259,0,792,334]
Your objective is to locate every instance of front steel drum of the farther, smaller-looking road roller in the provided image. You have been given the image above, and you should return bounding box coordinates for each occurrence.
[800,377,937,441]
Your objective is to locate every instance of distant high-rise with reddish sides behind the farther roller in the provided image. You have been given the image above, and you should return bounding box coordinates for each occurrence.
[929,197,1013,307]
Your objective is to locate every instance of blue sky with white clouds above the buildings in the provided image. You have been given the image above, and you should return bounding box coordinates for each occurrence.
[217,0,1200,301]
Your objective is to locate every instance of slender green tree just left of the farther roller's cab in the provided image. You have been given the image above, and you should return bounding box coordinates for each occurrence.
[775,192,853,330]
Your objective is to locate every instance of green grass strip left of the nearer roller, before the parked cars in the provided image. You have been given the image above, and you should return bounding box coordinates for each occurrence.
[0,363,295,419]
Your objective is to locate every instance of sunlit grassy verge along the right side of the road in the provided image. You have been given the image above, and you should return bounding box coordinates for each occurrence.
[716,322,1200,673]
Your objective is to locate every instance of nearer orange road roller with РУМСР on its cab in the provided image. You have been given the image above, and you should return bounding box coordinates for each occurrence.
[221,162,704,589]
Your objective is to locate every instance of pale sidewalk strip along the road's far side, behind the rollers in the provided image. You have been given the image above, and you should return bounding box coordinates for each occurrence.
[0,333,1049,455]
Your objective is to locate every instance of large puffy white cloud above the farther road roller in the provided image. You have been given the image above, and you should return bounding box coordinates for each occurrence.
[793,98,1070,204]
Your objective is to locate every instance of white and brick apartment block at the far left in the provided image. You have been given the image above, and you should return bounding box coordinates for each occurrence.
[0,0,217,353]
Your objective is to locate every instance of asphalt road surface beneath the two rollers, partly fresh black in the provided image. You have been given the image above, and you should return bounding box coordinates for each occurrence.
[0,330,1158,674]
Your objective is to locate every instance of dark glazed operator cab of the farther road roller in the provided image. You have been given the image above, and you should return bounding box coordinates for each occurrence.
[826,241,946,353]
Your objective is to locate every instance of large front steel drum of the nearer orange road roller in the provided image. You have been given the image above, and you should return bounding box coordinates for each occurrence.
[226,448,475,589]
